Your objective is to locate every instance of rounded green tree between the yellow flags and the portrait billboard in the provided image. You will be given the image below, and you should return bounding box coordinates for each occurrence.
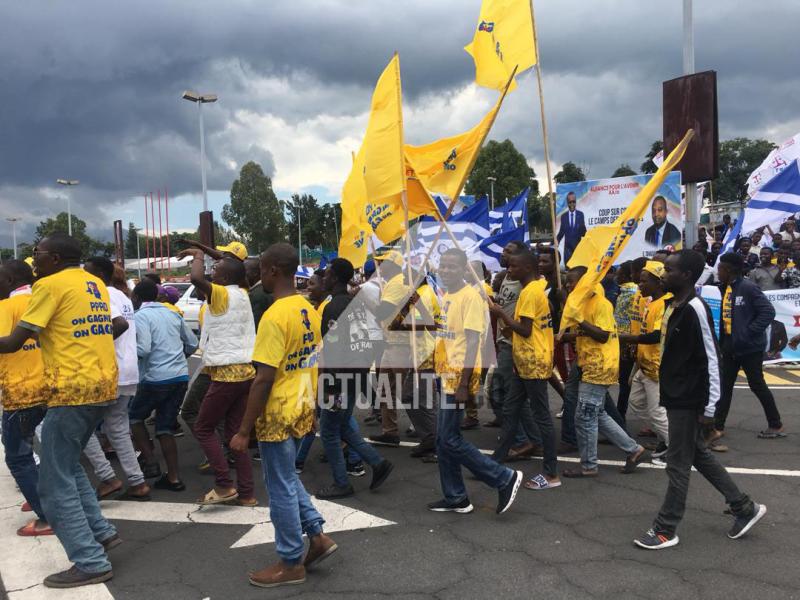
[465,140,539,206]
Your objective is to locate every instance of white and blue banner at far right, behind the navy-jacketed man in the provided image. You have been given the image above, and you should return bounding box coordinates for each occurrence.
[699,285,800,364]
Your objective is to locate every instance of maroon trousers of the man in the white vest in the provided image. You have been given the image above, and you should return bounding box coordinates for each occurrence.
[194,379,253,499]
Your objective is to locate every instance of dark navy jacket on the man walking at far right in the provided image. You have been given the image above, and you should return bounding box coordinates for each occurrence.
[719,277,775,356]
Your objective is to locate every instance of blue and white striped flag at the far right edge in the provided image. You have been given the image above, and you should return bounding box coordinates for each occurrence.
[741,159,800,233]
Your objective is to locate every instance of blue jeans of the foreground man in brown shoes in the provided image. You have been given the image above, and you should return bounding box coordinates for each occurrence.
[258,438,325,565]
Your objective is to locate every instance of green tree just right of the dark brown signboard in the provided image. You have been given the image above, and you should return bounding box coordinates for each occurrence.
[714,138,776,202]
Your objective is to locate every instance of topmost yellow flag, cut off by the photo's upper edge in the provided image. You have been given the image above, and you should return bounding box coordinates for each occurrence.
[464,0,537,90]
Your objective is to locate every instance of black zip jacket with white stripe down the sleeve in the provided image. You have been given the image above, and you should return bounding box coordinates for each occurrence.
[658,296,721,417]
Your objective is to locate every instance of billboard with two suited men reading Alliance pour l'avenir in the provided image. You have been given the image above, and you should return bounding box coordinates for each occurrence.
[556,171,684,263]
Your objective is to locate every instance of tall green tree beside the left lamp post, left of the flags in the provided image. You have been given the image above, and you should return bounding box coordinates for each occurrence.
[222,161,286,254]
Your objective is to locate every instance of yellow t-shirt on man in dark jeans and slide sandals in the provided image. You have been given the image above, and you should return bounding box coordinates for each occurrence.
[511,279,553,379]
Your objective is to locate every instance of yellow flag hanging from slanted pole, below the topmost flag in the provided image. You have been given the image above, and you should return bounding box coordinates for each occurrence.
[406,94,508,200]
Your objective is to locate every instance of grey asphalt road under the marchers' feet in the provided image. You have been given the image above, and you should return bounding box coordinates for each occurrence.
[0,376,800,600]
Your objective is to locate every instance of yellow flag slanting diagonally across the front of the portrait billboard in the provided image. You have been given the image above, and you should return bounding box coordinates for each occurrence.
[561,129,694,330]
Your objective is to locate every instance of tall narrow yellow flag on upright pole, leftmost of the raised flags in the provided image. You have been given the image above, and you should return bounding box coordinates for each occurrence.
[362,54,406,199]
